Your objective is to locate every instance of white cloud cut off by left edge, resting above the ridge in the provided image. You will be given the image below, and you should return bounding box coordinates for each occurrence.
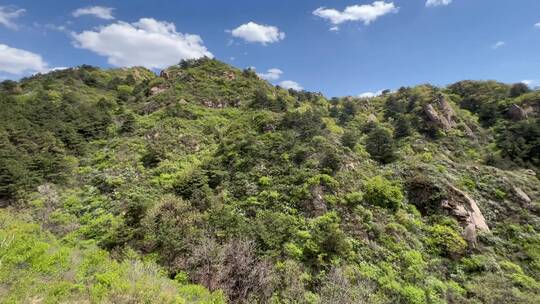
[0,44,47,75]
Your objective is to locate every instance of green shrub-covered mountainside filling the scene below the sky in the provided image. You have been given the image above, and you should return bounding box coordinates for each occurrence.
[0,59,540,304]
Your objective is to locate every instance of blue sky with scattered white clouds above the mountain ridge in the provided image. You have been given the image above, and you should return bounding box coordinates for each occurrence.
[0,0,540,97]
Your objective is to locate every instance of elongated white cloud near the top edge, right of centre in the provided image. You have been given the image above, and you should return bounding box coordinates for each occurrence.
[313,1,398,31]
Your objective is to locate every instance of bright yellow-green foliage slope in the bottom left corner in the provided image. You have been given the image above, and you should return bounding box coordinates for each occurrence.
[0,210,225,304]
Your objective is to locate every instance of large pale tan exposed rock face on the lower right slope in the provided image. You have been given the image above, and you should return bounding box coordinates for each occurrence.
[442,184,489,247]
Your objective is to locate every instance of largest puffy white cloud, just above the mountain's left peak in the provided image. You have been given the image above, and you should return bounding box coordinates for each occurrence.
[72,18,213,69]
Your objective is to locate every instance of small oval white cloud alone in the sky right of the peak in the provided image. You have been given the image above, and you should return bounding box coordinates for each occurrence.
[230,22,285,45]
